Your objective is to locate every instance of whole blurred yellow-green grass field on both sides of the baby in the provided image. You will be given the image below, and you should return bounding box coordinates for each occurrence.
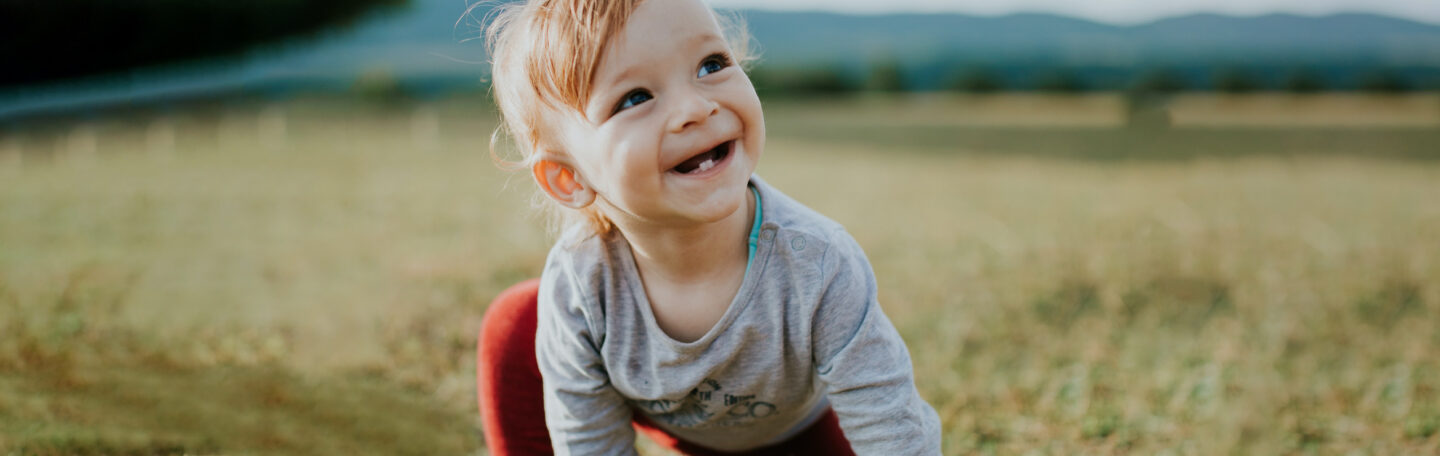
[0,95,1440,455]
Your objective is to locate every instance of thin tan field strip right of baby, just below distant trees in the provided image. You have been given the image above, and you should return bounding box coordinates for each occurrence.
[766,92,1440,128]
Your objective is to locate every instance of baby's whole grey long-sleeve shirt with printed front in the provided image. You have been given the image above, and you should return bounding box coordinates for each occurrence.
[536,177,940,455]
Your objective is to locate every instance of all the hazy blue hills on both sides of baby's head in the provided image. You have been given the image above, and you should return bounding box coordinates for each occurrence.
[0,0,1440,117]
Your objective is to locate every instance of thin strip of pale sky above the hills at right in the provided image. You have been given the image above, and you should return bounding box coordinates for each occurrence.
[708,0,1440,24]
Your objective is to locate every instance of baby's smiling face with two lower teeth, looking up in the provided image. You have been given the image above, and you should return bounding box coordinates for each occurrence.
[563,0,765,226]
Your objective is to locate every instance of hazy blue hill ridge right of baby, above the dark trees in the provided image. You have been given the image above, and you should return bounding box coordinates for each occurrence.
[744,12,1440,66]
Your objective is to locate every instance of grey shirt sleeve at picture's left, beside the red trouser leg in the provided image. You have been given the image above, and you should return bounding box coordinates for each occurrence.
[536,260,635,456]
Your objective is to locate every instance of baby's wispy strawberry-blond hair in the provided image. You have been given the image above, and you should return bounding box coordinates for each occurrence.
[485,0,750,234]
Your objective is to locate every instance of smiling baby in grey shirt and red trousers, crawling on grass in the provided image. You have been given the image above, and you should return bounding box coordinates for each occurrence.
[477,0,940,456]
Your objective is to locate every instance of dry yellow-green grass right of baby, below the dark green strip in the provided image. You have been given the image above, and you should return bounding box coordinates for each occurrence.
[768,140,1440,455]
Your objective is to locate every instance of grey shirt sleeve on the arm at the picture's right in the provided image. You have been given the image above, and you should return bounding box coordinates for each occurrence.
[812,230,940,455]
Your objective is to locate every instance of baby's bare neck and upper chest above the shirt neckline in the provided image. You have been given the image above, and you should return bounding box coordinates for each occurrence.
[611,190,756,283]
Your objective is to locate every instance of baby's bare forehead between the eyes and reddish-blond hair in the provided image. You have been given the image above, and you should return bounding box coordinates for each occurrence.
[595,0,723,79]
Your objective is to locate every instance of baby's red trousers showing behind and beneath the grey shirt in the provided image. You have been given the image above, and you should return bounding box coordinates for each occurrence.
[475,279,855,456]
